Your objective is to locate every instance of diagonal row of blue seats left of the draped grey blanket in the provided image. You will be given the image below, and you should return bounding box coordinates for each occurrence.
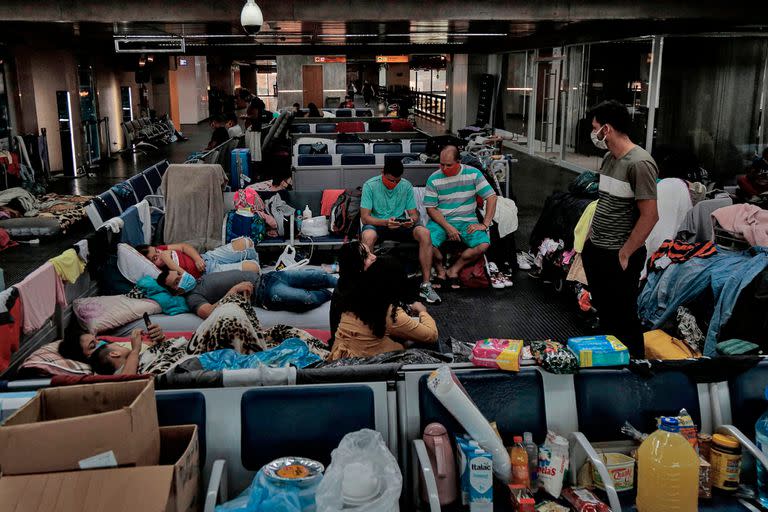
[85,160,170,229]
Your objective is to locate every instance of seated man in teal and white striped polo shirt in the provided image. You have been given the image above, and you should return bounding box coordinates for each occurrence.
[424,146,496,288]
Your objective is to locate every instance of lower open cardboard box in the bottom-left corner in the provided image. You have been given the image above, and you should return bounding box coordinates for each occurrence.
[0,425,200,512]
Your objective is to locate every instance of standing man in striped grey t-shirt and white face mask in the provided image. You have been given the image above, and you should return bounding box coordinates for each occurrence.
[582,100,659,358]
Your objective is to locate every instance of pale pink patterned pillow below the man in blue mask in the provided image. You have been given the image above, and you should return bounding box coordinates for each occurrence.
[73,295,162,333]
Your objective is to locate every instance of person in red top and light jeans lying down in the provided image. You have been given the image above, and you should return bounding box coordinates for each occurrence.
[136,237,260,279]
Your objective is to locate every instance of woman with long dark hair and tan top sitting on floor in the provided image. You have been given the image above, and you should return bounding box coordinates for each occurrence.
[329,258,437,360]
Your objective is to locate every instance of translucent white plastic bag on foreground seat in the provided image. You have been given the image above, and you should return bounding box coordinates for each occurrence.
[315,429,403,512]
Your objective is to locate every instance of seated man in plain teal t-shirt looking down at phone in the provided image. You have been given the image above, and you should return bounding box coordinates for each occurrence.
[360,159,440,304]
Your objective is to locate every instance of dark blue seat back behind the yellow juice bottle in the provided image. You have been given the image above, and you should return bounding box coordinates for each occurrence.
[574,369,701,442]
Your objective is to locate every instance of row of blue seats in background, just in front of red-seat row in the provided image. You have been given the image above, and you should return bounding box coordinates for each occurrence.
[293,139,427,167]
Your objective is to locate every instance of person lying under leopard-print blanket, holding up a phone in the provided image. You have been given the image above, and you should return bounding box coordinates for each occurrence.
[62,294,328,375]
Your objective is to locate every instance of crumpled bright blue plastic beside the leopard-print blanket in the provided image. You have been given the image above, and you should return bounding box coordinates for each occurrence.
[199,338,321,370]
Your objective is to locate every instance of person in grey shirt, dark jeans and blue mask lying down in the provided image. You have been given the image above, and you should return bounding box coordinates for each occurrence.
[157,269,337,318]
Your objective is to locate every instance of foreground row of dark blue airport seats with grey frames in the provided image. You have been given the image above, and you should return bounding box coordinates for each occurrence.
[0,361,768,512]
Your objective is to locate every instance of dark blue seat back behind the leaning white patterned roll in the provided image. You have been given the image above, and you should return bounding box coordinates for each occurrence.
[419,368,547,446]
